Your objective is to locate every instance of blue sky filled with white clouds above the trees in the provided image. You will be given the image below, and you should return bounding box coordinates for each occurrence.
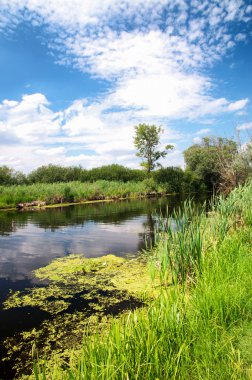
[0,0,252,172]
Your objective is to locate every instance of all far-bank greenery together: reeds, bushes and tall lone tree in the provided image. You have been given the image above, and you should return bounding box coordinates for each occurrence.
[0,134,252,208]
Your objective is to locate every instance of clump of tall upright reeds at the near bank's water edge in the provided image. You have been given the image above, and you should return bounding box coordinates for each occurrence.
[154,200,206,285]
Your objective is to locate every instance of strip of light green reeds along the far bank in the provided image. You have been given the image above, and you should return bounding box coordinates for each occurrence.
[0,180,167,208]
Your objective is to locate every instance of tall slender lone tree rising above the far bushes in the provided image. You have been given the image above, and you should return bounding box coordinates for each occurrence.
[134,124,173,174]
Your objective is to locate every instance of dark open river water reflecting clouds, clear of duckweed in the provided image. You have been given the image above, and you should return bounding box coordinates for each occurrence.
[0,196,189,379]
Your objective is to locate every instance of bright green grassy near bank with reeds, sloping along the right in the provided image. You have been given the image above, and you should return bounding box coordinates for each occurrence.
[31,184,252,380]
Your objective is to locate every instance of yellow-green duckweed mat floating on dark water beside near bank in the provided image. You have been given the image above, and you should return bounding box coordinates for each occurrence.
[4,255,159,378]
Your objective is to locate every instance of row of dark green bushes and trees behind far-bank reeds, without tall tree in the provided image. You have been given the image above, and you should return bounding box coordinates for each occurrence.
[0,137,252,193]
